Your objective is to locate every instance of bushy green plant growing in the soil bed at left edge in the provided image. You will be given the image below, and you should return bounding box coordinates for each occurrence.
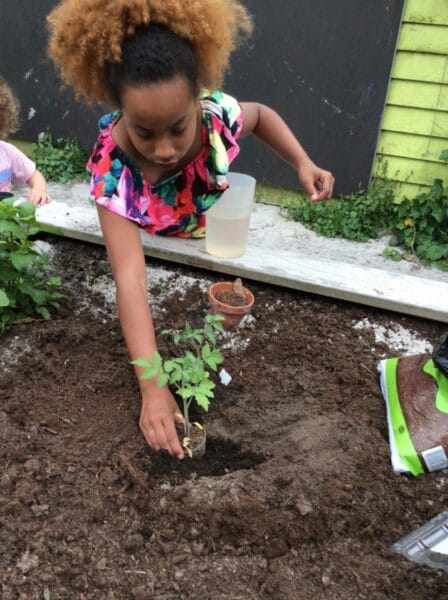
[0,198,63,333]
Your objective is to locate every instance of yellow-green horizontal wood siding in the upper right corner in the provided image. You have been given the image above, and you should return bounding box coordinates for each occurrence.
[373,0,448,202]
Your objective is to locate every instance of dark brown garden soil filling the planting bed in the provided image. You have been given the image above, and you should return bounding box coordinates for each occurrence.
[0,237,448,600]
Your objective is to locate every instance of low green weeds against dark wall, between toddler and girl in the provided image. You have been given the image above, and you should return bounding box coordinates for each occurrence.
[32,132,89,183]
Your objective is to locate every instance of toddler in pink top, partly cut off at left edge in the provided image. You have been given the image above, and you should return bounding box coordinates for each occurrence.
[0,77,51,206]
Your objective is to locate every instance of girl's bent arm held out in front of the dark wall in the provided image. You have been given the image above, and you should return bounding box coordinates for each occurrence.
[241,102,334,202]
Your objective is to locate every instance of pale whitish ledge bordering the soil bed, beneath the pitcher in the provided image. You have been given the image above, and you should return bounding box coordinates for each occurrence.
[37,186,448,323]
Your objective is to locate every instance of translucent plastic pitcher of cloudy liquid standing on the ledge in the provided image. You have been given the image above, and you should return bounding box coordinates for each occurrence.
[205,173,256,258]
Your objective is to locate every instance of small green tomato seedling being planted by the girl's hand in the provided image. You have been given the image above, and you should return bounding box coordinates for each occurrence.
[132,315,224,437]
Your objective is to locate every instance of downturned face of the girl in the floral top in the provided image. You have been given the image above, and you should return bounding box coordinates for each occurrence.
[121,76,198,170]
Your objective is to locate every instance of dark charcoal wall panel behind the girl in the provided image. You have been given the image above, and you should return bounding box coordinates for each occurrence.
[0,0,403,193]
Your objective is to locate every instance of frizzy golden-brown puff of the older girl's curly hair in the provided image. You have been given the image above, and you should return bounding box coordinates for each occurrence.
[47,0,252,104]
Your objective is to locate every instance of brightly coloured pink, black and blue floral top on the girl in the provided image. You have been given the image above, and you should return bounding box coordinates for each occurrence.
[87,91,243,237]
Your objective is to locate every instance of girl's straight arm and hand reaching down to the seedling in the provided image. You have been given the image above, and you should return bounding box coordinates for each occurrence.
[97,205,184,458]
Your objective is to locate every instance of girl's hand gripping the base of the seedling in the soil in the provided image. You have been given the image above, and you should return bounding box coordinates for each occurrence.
[140,387,184,459]
